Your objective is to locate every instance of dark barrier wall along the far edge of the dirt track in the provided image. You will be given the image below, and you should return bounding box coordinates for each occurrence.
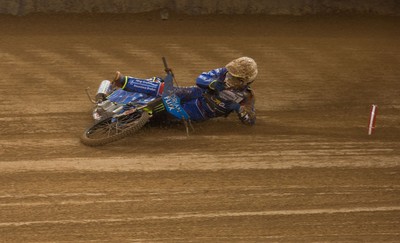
[0,0,400,16]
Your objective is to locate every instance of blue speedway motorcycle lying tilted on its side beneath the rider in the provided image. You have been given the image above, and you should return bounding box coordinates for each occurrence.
[80,57,191,146]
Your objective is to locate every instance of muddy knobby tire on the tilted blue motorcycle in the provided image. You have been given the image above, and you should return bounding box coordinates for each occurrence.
[81,112,150,146]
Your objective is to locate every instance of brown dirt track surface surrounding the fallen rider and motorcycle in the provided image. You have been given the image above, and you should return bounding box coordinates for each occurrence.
[0,15,400,242]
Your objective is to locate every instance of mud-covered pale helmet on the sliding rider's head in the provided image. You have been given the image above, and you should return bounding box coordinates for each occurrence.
[226,57,258,85]
